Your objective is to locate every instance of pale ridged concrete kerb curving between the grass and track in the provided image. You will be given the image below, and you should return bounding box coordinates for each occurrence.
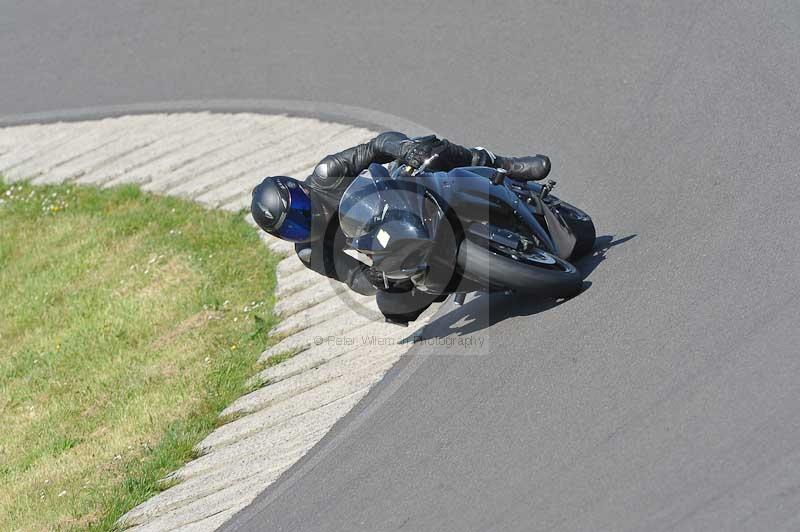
[0,100,435,530]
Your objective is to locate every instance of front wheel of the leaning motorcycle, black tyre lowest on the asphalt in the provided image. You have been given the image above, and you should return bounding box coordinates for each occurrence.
[458,240,582,297]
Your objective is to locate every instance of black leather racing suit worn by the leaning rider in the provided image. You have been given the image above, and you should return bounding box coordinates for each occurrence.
[295,132,504,322]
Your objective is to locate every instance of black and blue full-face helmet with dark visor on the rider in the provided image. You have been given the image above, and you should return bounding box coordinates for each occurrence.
[250,176,311,242]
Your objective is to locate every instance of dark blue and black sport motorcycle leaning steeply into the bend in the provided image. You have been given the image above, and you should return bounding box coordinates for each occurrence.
[339,155,595,304]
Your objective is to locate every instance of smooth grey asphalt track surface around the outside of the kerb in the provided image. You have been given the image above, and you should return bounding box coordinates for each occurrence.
[0,0,800,531]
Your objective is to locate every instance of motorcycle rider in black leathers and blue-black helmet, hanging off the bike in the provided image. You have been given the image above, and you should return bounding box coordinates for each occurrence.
[251,131,550,325]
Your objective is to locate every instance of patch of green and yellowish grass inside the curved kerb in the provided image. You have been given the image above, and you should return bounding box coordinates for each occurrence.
[0,180,277,530]
